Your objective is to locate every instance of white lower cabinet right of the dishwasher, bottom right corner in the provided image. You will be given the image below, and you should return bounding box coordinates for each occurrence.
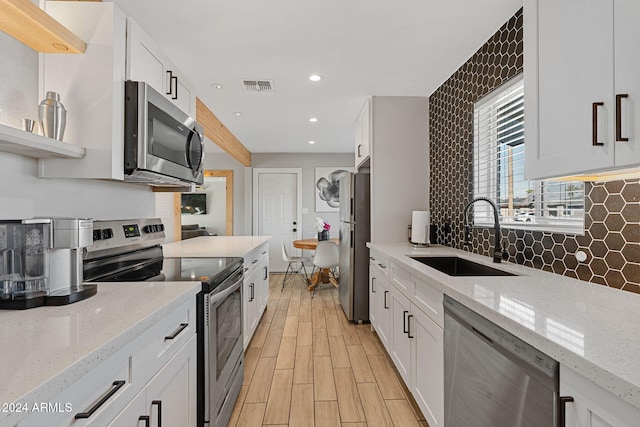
[560,365,640,427]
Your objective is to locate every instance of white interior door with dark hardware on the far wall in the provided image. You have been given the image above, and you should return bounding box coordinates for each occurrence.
[254,170,301,271]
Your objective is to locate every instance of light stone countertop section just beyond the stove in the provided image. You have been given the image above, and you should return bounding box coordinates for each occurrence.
[162,236,271,258]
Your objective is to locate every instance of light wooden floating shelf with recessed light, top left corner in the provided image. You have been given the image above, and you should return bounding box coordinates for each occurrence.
[0,0,87,53]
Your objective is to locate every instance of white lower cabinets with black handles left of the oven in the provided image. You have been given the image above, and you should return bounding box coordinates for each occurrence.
[18,298,197,427]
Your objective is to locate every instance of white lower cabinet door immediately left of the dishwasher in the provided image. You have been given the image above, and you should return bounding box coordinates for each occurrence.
[409,304,444,427]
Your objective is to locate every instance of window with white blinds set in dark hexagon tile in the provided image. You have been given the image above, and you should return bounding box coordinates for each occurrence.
[473,75,584,233]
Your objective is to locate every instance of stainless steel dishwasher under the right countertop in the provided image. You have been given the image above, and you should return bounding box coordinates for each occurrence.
[444,296,564,427]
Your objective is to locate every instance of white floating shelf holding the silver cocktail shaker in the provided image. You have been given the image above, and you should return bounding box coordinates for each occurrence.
[0,125,85,159]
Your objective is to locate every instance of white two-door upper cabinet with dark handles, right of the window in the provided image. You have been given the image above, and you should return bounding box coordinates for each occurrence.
[524,0,640,179]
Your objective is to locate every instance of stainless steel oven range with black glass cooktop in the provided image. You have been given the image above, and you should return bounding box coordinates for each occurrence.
[83,219,244,427]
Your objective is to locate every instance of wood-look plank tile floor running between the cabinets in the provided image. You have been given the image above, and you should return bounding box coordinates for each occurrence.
[229,274,428,427]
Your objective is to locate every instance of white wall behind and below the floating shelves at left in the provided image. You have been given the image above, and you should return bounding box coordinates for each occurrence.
[0,32,155,219]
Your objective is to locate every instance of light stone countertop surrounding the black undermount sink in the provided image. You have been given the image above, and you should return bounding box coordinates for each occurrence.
[368,243,640,408]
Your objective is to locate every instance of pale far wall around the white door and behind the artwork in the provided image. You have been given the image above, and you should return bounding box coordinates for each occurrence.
[251,153,355,239]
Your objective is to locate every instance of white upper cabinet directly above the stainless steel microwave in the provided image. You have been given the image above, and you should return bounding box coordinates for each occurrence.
[127,18,196,117]
